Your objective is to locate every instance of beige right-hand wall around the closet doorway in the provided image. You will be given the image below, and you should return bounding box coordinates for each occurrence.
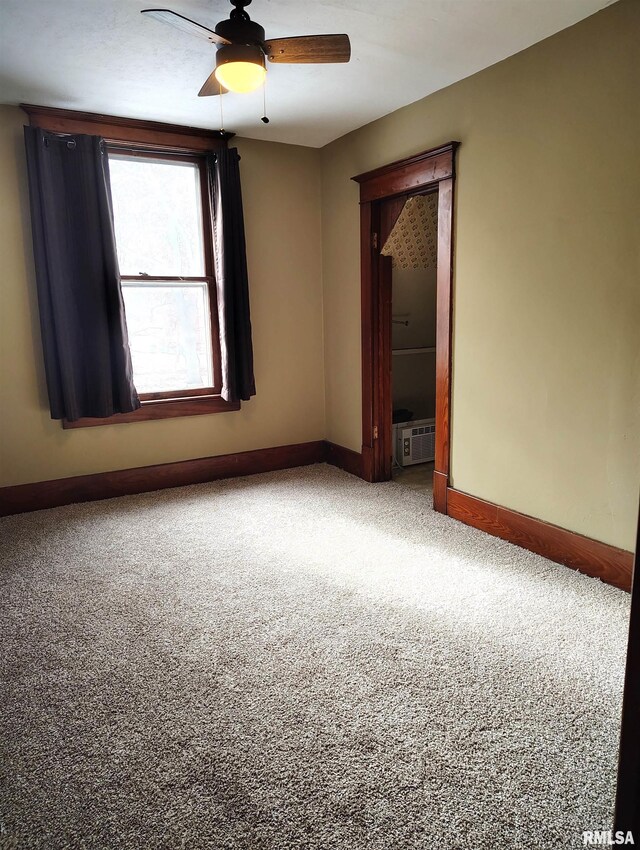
[322,0,640,549]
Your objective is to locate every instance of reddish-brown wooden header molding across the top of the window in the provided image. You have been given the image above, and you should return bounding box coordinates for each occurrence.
[20,103,234,151]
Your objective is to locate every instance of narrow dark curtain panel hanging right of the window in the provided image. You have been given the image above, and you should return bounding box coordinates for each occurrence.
[208,148,256,401]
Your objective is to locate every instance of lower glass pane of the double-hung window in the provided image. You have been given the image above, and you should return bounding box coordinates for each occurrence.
[122,280,213,393]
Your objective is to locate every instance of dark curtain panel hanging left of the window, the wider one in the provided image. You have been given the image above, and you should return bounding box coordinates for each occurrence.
[24,127,140,420]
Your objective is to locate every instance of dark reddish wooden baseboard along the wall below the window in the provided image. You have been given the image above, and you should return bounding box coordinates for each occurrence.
[0,440,326,516]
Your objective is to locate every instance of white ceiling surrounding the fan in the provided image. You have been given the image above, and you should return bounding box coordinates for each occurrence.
[0,0,613,147]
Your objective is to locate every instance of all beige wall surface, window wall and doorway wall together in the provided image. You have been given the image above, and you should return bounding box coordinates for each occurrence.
[0,0,640,549]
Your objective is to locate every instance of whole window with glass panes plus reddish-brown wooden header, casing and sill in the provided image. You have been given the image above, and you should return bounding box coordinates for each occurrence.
[23,106,245,428]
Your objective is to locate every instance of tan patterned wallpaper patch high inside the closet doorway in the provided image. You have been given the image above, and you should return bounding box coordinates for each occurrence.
[380,192,438,269]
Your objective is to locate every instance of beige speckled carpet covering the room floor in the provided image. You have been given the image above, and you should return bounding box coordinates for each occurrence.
[0,465,629,850]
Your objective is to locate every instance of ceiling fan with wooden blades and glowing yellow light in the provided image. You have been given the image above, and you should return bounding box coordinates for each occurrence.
[142,0,351,97]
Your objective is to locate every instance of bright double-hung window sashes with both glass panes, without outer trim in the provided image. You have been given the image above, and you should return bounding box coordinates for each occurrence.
[109,149,221,402]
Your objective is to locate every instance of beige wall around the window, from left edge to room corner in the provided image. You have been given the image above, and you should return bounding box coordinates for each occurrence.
[0,107,325,486]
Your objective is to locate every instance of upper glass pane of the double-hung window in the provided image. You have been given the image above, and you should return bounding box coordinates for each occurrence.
[109,154,205,277]
